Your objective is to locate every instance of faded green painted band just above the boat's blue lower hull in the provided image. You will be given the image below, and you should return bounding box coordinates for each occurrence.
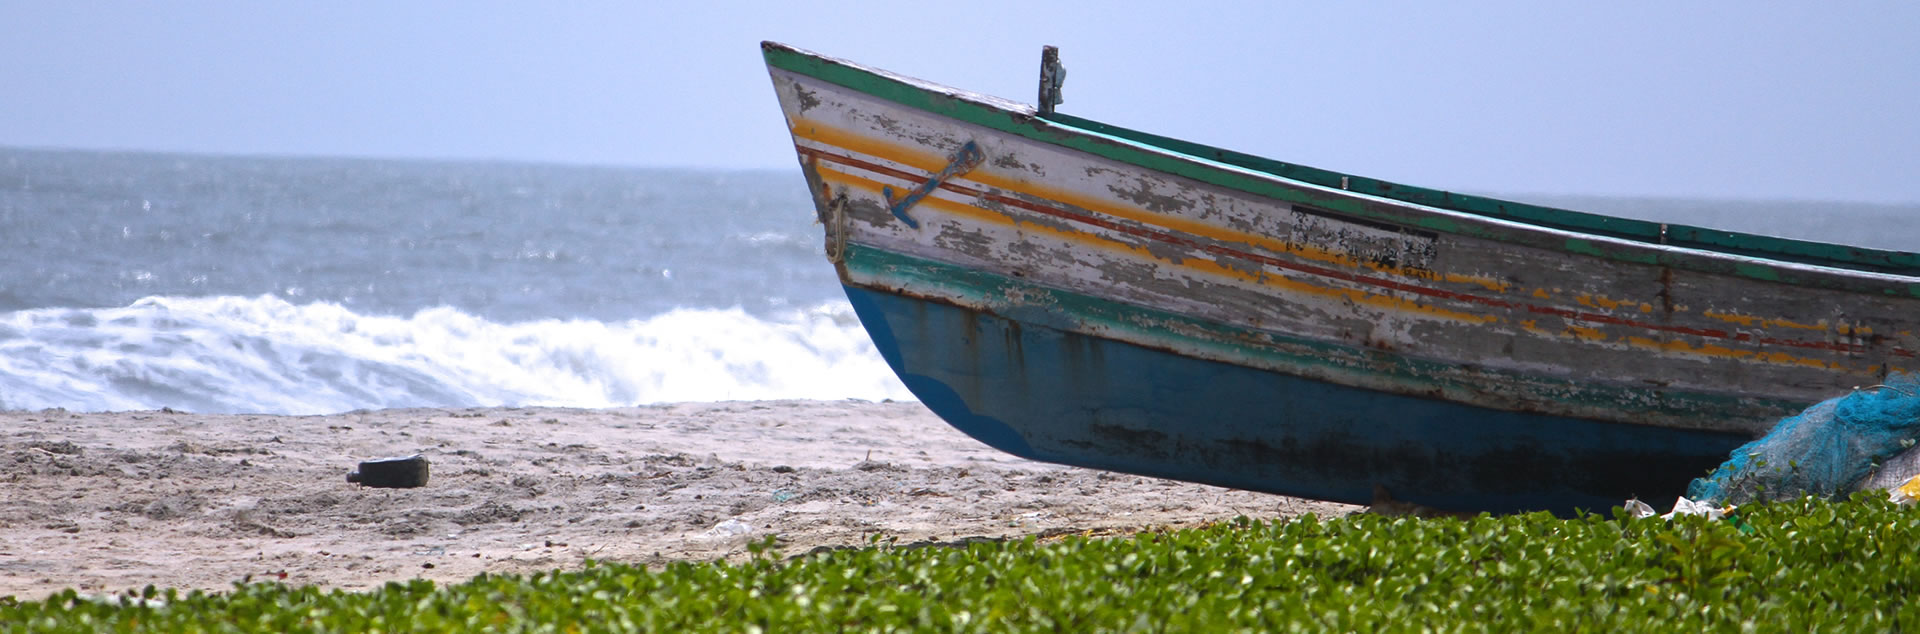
[845,242,1811,430]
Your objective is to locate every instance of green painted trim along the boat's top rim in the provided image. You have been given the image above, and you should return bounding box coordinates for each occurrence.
[762,42,1920,298]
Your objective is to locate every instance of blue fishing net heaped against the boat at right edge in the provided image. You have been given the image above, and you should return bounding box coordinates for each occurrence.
[1686,375,1920,505]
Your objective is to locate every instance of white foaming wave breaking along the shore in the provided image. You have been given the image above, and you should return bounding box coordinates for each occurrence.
[0,296,912,415]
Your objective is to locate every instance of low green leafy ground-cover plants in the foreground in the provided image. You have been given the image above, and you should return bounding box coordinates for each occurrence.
[0,496,1920,632]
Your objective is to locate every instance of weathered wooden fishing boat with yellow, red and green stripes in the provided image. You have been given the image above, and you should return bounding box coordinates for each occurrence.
[762,42,1920,513]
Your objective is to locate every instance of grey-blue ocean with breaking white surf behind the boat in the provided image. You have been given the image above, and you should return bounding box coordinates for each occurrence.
[0,148,1920,415]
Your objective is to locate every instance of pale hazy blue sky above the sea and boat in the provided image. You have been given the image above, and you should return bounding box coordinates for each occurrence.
[0,0,1920,202]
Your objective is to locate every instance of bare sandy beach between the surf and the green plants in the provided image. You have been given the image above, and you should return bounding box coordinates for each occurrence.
[0,402,1359,599]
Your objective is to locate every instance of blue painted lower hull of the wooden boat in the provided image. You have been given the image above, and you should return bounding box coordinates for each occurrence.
[845,286,1747,515]
